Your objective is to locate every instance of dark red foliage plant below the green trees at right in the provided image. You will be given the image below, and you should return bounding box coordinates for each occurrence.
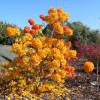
[75,41,100,58]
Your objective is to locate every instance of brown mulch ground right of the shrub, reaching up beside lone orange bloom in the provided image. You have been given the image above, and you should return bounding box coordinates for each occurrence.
[66,59,100,100]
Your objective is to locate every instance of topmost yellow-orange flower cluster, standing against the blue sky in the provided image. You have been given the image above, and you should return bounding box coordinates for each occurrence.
[40,8,69,24]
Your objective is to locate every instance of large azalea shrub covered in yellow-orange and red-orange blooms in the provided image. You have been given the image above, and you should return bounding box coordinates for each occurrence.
[1,8,77,98]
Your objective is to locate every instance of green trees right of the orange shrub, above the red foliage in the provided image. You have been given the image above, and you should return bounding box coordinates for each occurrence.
[67,22,100,44]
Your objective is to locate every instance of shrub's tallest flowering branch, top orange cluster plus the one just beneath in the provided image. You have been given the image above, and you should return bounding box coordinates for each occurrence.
[40,8,73,36]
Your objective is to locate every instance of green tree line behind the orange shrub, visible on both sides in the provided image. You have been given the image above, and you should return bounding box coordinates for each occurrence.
[0,21,100,45]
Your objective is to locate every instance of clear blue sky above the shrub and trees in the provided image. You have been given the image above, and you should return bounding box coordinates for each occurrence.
[0,0,100,29]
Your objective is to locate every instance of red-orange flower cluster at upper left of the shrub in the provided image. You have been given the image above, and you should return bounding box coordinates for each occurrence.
[24,18,42,35]
